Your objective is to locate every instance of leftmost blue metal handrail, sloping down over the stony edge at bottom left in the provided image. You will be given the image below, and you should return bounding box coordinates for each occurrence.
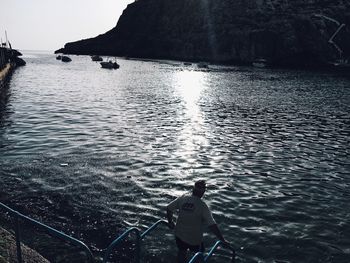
[0,202,94,263]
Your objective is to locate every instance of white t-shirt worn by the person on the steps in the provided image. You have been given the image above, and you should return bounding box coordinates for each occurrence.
[167,195,216,246]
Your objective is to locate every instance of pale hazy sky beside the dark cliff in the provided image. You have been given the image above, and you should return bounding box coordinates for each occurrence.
[0,0,134,50]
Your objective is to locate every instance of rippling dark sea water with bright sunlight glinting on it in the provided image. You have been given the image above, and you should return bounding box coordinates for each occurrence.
[0,52,350,263]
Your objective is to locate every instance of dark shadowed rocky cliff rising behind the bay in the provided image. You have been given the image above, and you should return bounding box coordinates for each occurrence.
[56,0,350,66]
